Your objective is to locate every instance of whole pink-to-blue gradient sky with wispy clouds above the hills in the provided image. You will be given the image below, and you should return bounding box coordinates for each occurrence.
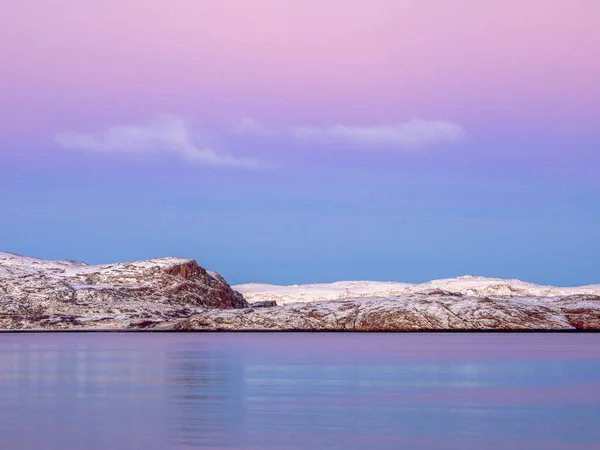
[0,0,600,285]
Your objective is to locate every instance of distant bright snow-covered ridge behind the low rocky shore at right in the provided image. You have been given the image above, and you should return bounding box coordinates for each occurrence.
[234,275,600,305]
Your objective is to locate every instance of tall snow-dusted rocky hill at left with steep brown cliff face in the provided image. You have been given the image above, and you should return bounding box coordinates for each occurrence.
[0,253,248,329]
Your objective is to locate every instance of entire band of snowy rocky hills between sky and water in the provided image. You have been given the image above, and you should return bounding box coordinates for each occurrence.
[0,253,600,331]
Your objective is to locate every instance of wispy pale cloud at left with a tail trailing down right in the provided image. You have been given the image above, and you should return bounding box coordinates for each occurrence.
[54,115,258,169]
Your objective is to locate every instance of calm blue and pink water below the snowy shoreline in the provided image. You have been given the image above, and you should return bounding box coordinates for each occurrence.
[0,333,600,450]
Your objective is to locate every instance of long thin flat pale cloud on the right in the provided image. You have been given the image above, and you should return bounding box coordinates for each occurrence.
[238,118,466,149]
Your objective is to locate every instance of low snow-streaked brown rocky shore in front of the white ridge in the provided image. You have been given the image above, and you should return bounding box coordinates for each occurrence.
[174,292,600,331]
